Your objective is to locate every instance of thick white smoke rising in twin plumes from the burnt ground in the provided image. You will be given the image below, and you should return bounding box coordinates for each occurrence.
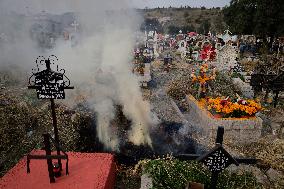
[0,0,154,150]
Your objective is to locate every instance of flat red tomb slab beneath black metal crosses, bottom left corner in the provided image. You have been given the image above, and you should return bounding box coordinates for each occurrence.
[0,150,116,189]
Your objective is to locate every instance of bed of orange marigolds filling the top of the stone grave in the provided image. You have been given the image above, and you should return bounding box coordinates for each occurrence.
[207,97,262,118]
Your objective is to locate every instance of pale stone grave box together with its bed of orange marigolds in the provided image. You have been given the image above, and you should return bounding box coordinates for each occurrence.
[186,94,262,144]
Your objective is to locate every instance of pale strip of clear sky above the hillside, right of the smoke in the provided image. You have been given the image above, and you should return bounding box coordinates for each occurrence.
[131,0,230,8]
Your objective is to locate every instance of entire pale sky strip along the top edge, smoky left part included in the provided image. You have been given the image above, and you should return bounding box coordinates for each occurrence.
[0,0,230,13]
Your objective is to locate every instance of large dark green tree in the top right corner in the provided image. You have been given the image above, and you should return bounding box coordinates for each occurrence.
[223,0,284,36]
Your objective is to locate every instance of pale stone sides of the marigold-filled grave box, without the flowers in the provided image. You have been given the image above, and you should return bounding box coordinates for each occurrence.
[186,95,262,144]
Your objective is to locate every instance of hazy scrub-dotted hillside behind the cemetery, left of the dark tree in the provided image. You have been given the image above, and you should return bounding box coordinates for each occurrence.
[140,7,226,33]
